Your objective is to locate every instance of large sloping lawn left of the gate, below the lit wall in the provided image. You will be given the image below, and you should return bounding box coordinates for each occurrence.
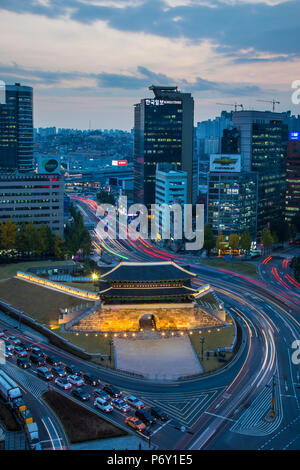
[0,278,93,325]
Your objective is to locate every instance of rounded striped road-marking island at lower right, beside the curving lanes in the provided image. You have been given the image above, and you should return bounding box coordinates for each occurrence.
[230,380,283,436]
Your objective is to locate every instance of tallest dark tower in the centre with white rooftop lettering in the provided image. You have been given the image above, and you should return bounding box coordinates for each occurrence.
[134,86,197,206]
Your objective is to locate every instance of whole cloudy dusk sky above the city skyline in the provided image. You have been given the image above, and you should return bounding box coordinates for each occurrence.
[0,0,300,130]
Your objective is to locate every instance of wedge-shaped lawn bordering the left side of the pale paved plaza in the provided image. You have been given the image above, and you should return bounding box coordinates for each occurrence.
[55,331,114,367]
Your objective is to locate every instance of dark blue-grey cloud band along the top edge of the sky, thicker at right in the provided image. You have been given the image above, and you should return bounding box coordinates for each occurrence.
[0,0,300,56]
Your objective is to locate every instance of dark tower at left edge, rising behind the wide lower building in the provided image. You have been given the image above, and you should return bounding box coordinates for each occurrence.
[0,83,33,173]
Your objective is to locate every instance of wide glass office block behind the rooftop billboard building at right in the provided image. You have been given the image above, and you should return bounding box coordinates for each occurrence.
[232,111,288,231]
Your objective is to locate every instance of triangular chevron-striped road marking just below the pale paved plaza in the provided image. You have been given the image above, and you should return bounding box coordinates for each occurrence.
[120,387,224,428]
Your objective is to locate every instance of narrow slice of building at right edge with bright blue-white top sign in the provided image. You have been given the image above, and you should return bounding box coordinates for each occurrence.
[285,132,300,222]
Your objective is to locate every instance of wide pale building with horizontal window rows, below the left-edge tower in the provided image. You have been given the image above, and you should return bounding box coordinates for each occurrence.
[0,173,64,237]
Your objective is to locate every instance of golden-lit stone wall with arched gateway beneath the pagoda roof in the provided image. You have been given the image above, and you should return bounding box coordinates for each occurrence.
[72,306,223,331]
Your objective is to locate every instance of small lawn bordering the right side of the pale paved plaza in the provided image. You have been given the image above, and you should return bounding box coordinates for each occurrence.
[190,317,235,372]
